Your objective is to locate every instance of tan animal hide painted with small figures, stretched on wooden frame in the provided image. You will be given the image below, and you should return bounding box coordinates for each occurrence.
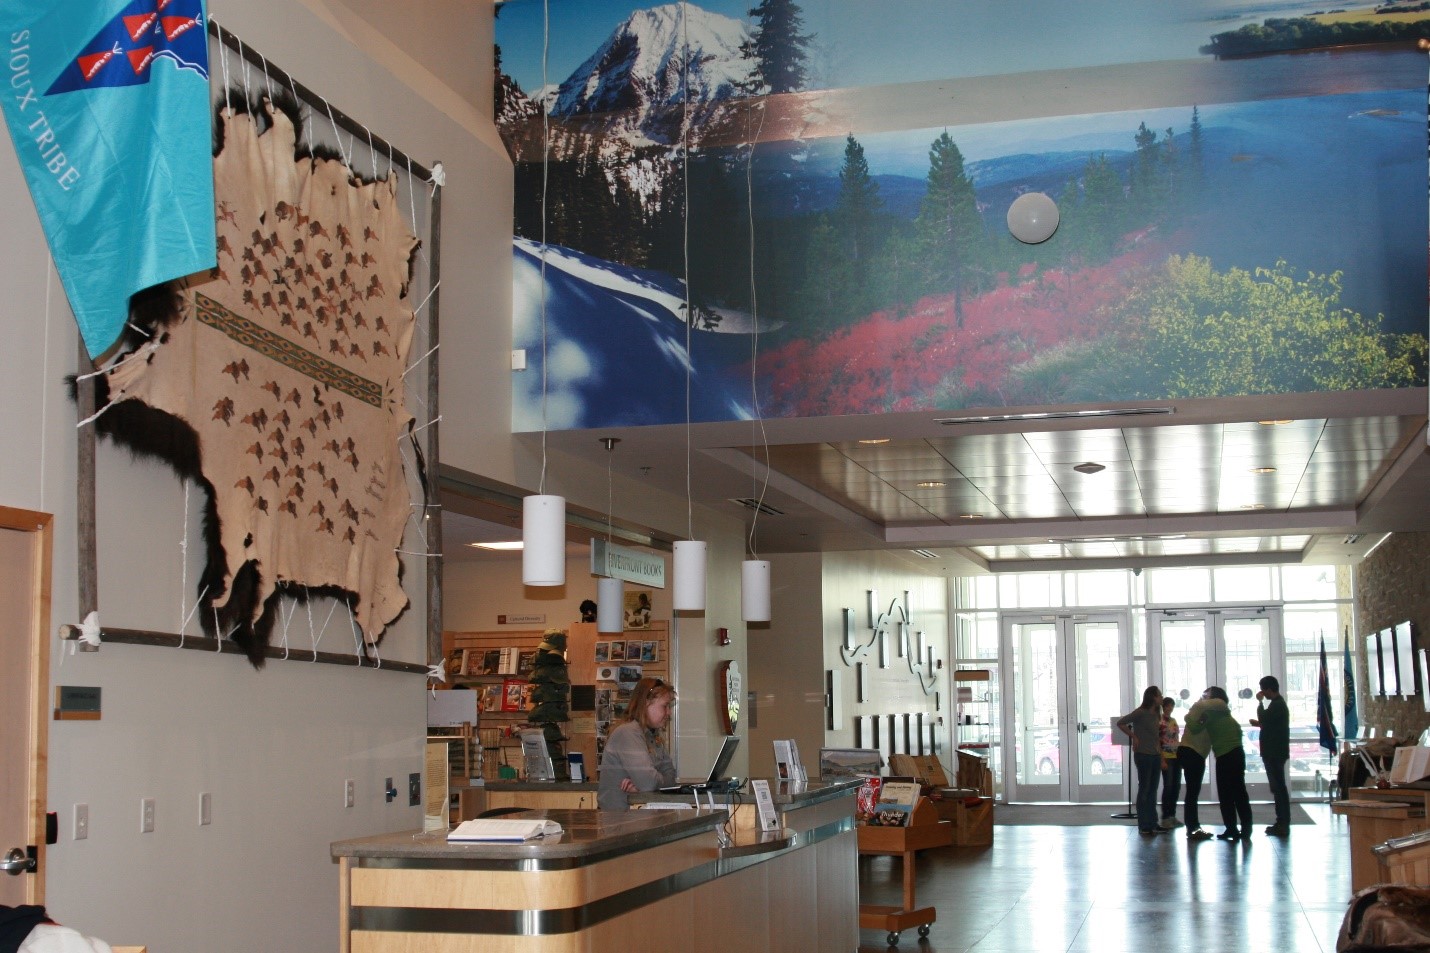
[109,109,416,657]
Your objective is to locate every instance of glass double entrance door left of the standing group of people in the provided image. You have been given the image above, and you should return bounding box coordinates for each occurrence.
[1002,614,1130,801]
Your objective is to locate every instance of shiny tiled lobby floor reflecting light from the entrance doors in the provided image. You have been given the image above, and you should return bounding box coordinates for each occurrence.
[859,804,1350,953]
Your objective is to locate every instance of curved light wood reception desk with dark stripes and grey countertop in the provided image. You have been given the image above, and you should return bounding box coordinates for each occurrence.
[332,783,859,953]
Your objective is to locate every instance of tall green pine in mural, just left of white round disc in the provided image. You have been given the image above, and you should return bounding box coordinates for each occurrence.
[917,132,985,328]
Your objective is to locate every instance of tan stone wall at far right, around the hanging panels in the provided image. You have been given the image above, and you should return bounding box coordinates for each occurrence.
[1356,532,1430,738]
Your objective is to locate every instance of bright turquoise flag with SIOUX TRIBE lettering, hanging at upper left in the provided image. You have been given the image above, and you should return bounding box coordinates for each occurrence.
[0,0,215,358]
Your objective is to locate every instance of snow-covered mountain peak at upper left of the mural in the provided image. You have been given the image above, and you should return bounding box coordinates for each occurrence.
[551,3,749,143]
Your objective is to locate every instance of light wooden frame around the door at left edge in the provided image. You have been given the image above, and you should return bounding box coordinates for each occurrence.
[0,505,54,904]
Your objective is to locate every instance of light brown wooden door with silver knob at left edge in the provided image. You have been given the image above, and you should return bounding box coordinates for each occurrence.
[0,507,51,907]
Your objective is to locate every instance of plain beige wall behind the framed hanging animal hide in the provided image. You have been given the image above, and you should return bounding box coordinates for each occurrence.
[0,0,513,953]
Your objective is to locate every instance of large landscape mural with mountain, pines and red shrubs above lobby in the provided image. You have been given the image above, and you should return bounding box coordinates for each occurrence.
[496,0,1430,431]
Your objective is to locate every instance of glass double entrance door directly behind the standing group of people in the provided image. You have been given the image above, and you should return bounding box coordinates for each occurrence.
[1148,607,1284,800]
